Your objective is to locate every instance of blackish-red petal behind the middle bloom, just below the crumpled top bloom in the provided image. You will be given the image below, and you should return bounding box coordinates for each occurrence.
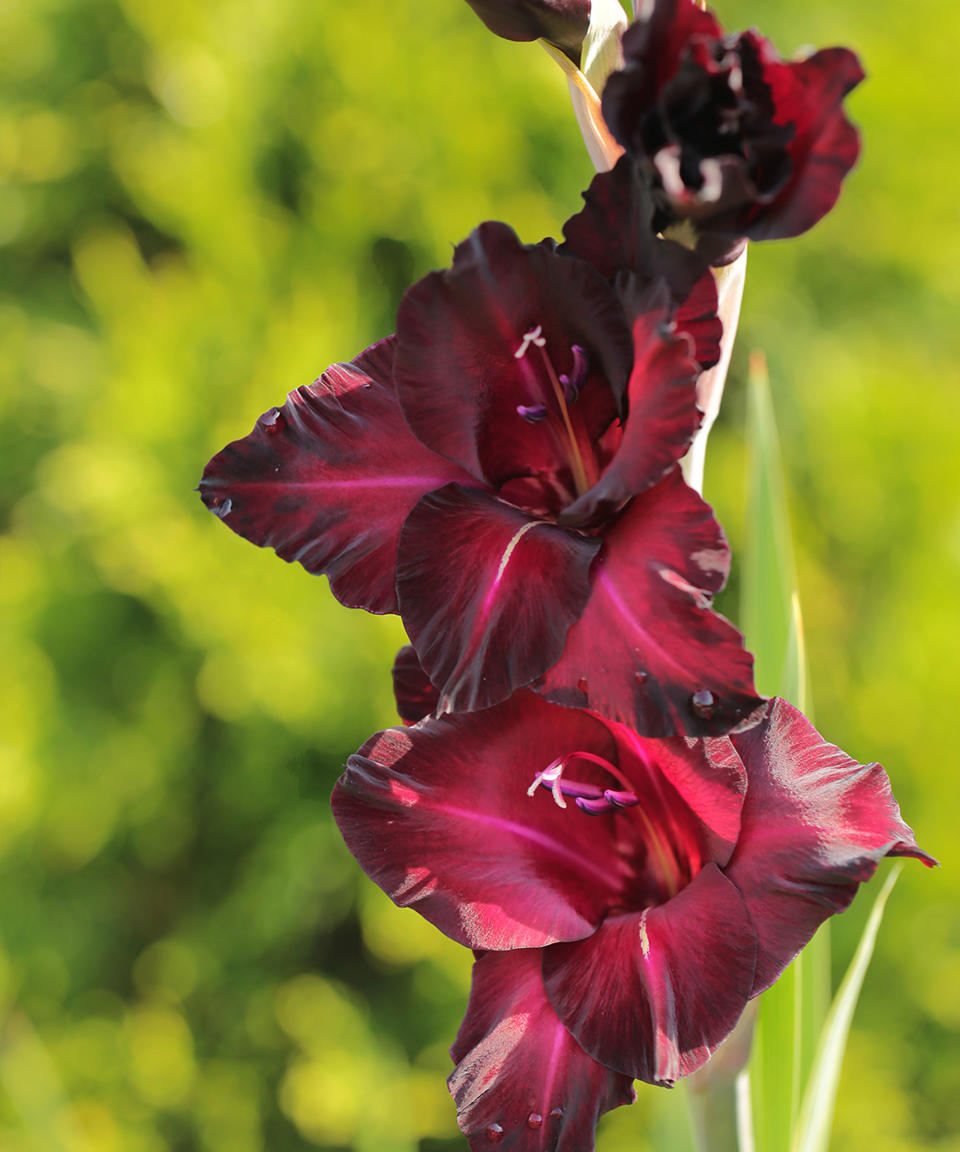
[559,156,723,367]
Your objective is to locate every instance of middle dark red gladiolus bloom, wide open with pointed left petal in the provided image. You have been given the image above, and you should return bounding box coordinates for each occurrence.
[199,220,758,735]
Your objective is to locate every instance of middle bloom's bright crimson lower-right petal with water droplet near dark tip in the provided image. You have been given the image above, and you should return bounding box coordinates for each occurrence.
[539,469,759,736]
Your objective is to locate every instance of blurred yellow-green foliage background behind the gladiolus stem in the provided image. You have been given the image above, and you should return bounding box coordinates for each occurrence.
[0,0,960,1152]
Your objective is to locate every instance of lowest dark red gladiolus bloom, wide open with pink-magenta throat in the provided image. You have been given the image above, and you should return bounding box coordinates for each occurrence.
[333,691,933,1152]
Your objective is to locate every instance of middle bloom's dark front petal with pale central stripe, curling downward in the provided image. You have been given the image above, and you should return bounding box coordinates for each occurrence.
[396,484,600,712]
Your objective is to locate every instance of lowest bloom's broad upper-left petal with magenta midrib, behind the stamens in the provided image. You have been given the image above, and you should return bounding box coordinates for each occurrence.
[333,692,623,950]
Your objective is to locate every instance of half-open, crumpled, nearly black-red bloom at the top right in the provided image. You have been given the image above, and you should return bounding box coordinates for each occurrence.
[603,0,863,262]
